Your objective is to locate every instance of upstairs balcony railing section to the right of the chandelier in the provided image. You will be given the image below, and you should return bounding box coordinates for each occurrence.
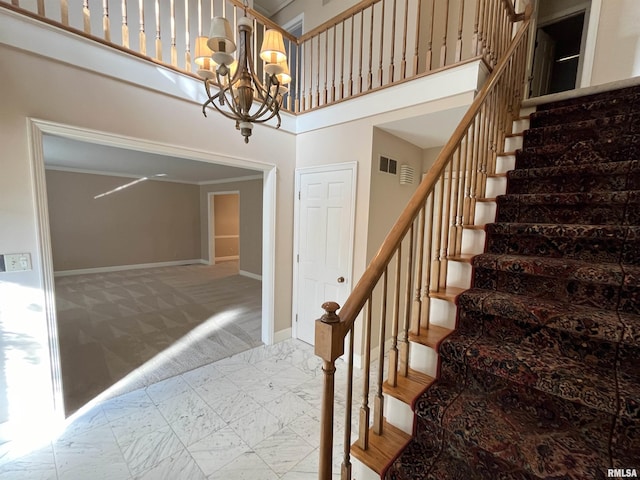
[295,0,521,112]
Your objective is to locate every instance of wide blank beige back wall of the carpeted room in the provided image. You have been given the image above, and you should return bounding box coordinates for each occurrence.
[46,170,200,271]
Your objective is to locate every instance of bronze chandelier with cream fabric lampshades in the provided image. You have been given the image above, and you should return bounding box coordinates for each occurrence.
[195,1,291,143]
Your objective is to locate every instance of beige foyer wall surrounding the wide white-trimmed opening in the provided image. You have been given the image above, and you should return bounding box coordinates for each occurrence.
[0,35,295,432]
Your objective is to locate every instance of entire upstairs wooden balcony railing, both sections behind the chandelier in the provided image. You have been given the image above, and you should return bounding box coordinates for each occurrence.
[0,0,519,113]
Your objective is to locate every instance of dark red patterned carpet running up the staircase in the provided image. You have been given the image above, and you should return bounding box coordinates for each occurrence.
[386,87,640,480]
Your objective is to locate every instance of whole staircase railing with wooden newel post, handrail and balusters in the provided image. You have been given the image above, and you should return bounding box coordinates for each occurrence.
[315,5,531,480]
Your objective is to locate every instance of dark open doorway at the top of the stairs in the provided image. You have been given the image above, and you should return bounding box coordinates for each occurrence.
[529,10,586,97]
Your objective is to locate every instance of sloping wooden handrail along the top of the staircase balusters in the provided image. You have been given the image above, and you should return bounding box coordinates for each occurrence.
[330,7,530,334]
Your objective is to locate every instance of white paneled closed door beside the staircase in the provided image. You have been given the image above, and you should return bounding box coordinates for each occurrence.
[294,164,355,344]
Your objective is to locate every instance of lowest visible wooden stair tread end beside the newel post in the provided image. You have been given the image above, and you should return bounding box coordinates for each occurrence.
[351,420,411,475]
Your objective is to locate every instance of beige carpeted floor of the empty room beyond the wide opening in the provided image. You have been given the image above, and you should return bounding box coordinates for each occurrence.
[56,262,262,414]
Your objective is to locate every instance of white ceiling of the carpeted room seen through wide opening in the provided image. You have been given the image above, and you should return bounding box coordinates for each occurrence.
[43,135,262,188]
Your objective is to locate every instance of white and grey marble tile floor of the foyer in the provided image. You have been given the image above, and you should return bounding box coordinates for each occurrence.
[0,339,370,480]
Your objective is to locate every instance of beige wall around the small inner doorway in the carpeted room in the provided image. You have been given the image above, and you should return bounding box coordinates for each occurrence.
[200,179,262,276]
